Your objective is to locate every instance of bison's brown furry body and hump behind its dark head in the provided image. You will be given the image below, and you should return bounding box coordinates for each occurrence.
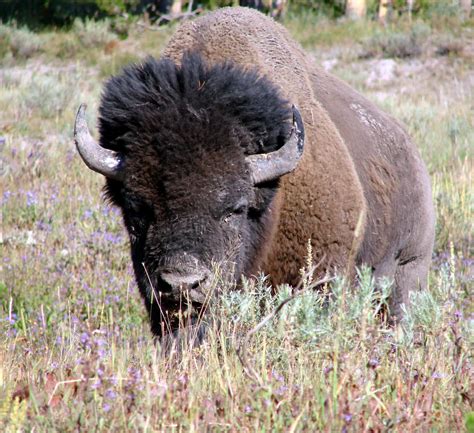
[164,8,434,316]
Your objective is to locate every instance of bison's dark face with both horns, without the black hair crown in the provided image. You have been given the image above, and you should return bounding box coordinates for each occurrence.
[75,101,304,324]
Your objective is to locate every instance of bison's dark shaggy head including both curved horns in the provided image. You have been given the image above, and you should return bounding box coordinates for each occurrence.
[74,54,304,334]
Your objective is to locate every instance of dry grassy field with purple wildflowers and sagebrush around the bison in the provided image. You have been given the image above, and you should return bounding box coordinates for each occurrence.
[0,10,474,432]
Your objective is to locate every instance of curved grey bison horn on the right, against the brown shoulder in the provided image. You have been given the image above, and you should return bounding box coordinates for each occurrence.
[245,105,304,185]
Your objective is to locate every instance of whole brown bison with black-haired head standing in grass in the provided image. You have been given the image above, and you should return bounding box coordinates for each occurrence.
[75,8,434,335]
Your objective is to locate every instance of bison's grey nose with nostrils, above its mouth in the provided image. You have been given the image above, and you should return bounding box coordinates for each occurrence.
[158,270,210,302]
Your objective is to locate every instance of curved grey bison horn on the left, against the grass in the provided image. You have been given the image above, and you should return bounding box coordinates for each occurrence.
[74,104,123,180]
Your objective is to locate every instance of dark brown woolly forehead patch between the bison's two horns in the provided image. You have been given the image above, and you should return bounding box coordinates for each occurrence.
[120,102,253,188]
